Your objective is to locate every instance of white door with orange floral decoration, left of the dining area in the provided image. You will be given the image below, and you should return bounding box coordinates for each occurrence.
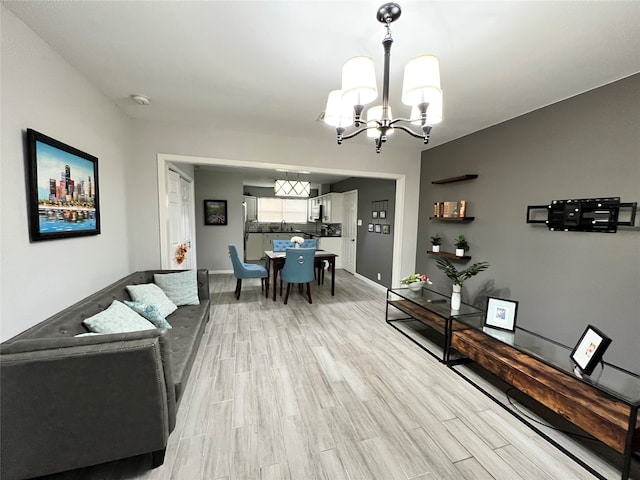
[167,170,195,270]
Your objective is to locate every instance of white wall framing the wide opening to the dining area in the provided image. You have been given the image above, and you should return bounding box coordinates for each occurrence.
[128,121,422,284]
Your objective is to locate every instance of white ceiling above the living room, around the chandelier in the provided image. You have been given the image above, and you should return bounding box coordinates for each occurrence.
[3,0,640,185]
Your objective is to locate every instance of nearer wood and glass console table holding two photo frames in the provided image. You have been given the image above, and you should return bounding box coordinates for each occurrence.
[446,314,640,480]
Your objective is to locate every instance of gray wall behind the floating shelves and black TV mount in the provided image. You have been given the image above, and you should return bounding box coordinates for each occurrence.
[416,75,640,373]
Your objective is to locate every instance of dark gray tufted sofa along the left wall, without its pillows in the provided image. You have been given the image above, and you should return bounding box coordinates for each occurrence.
[0,270,210,480]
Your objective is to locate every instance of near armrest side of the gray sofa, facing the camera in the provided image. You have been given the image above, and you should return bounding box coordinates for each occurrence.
[0,329,176,479]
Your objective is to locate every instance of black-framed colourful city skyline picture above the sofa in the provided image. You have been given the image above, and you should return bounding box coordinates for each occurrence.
[26,128,100,242]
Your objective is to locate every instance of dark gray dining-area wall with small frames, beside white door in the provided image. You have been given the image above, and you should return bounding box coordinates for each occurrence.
[331,178,396,287]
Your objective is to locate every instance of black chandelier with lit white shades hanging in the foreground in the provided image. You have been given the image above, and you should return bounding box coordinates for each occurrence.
[324,3,442,153]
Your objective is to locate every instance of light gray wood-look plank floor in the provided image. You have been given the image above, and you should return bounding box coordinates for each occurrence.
[38,270,637,480]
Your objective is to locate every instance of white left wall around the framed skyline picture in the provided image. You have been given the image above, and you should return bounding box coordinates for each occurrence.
[0,6,131,340]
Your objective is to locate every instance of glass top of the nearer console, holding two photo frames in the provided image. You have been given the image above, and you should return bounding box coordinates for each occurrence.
[457,313,640,405]
